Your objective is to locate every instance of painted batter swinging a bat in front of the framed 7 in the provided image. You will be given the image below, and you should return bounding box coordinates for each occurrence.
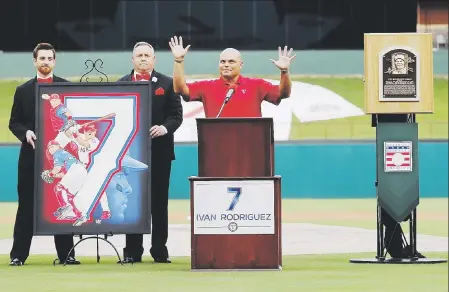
[73,124,111,220]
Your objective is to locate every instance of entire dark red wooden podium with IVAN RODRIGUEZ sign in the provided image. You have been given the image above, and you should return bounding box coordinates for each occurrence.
[189,118,282,270]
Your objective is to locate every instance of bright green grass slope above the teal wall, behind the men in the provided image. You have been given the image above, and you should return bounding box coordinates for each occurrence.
[0,76,448,142]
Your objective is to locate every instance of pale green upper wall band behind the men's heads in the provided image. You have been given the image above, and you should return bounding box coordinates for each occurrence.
[0,49,448,79]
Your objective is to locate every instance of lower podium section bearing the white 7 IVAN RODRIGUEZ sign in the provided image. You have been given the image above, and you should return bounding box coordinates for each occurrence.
[189,176,282,270]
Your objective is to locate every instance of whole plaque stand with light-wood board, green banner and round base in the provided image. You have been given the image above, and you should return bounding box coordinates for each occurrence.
[350,33,446,264]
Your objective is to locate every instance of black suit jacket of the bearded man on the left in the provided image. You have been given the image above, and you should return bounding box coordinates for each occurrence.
[9,74,70,171]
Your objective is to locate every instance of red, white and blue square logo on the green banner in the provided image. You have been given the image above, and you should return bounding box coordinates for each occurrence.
[384,141,412,172]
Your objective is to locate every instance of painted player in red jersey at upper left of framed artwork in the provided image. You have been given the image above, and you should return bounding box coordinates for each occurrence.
[42,93,76,148]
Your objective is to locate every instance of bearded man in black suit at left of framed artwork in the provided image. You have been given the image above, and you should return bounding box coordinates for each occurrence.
[9,43,80,266]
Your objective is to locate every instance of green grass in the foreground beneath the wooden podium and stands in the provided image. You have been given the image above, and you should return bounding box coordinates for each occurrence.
[0,253,448,292]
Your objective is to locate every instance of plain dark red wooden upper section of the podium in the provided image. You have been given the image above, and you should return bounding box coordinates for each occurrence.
[197,118,274,177]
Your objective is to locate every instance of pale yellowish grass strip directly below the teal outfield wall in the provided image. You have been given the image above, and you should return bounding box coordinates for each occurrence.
[0,198,449,239]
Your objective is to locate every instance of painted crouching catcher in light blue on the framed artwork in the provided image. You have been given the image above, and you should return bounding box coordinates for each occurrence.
[41,140,87,219]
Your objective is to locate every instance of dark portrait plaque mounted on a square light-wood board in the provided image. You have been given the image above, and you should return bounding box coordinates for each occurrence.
[364,33,434,114]
